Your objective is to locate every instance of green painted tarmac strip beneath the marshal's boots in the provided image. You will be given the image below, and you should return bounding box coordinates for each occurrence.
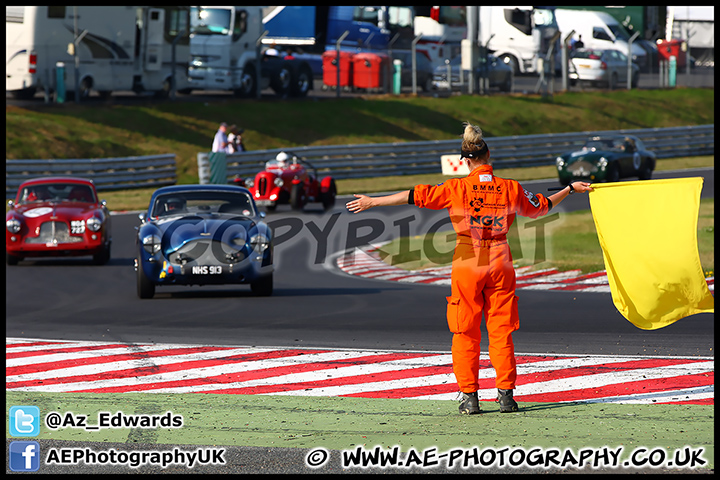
[6,391,715,470]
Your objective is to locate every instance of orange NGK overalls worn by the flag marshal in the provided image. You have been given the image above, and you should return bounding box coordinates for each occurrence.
[412,165,552,393]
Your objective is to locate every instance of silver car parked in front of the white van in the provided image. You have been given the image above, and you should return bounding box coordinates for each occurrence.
[568,48,640,90]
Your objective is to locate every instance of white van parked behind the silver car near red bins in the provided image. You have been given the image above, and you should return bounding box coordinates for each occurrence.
[555,8,648,70]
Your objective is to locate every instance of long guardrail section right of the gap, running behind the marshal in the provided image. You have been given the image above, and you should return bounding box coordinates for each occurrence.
[197,124,715,182]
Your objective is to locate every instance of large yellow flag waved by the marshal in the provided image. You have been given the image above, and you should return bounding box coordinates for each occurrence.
[589,177,715,330]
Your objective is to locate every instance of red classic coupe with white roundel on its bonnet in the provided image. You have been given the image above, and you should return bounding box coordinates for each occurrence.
[5,177,112,265]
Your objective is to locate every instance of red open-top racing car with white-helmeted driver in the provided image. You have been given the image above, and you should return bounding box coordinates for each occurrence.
[235,152,337,211]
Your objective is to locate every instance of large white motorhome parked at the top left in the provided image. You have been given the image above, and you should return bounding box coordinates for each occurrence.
[5,6,190,98]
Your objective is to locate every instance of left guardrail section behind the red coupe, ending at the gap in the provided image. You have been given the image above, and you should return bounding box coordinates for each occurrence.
[5,153,177,198]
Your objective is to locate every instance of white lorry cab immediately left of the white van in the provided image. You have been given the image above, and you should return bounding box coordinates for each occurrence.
[478,6,558,73]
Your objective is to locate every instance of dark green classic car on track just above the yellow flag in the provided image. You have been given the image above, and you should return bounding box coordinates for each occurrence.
[555,135,656,185]
